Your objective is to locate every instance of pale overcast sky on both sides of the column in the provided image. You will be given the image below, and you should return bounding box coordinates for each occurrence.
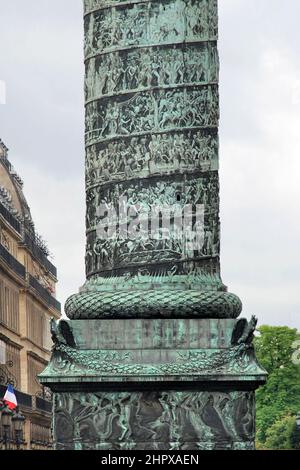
[0,0,300,329]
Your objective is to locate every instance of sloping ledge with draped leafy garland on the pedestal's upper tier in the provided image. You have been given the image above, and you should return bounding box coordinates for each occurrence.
[45,344,260,376]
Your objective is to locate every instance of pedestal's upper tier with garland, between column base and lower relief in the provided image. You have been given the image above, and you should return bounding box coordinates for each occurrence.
[42,318,265,382]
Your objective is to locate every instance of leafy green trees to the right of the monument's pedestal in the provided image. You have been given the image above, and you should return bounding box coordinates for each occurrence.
[255,326,300,448]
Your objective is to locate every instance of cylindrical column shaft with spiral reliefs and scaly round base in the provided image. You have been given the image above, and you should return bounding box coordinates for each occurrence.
[66,0,242,319]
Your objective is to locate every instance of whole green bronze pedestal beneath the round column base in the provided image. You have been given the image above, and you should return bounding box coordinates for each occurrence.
[40,319,265,450]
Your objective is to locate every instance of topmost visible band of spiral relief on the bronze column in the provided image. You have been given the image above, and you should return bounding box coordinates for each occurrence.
[85,0,217,56]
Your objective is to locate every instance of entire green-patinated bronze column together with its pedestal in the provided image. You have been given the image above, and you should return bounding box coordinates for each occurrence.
[40,0,266,450]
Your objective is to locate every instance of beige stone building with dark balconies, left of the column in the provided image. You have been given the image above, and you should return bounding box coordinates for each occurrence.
[0,140,60,449]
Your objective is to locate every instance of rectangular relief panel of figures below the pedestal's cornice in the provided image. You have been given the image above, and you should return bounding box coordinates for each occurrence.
[54,391,254,450]
